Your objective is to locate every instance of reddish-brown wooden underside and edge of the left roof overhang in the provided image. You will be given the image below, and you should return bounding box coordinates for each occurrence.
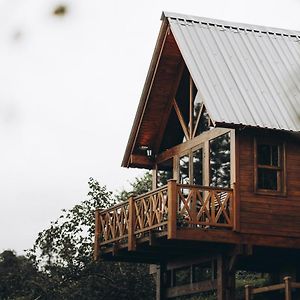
[122,17,183,169]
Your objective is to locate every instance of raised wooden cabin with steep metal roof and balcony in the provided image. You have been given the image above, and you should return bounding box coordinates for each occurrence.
[95,12,300,300]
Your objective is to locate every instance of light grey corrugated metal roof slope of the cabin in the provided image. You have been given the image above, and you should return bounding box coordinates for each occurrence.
[163,13,300,131]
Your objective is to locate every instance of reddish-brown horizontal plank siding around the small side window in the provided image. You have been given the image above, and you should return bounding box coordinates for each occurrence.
[237,130,300,237]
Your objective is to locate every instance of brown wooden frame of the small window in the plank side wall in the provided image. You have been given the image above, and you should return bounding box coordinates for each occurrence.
[254,137,287,196]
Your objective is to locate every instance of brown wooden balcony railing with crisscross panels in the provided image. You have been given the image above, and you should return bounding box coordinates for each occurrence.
[95,180,234,256]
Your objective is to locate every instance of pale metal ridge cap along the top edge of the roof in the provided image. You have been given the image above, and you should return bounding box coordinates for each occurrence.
[162,11,300,39]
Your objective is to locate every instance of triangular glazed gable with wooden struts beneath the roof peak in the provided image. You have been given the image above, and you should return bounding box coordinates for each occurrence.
[160,67,213,151]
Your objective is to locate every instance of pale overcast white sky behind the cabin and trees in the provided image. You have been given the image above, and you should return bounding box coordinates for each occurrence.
[0,0,300,253]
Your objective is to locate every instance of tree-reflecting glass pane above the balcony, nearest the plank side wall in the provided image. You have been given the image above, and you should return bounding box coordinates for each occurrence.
[209,133,230,187]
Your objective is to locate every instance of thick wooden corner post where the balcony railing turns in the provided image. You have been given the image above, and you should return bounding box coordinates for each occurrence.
[168,179,177,239]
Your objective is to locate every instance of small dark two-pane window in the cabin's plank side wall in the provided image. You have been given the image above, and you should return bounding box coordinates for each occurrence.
[255,141,285,193]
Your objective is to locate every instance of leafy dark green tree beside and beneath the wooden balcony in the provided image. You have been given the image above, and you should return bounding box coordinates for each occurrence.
[28,173,154,300]
